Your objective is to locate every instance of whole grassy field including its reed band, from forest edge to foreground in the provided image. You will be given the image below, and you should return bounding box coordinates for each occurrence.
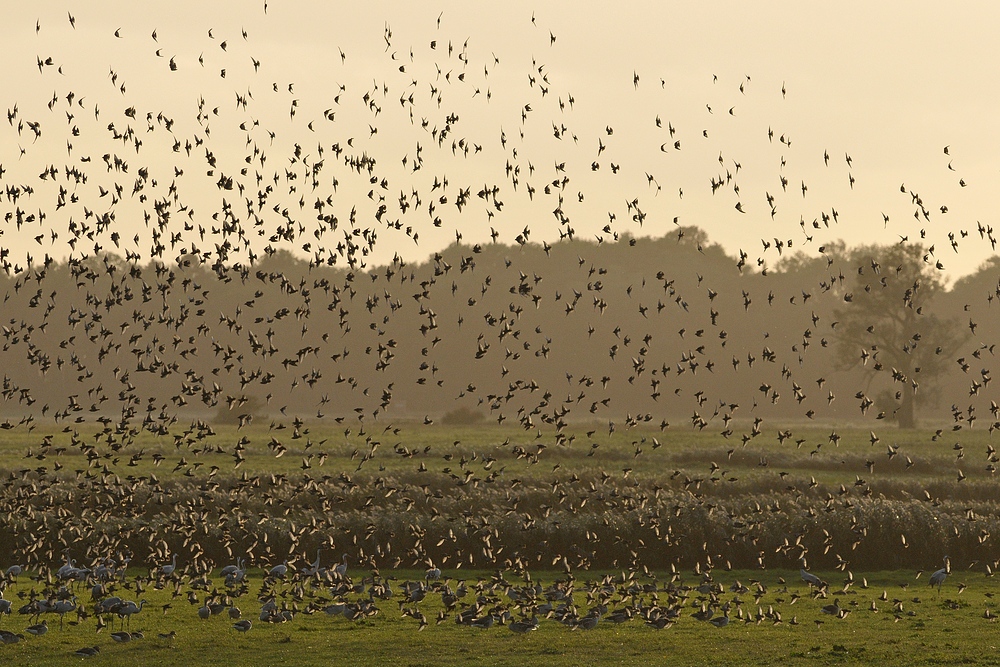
[0,423,1000,666]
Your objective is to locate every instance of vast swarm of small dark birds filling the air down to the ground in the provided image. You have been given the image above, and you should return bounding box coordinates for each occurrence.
[0,4,1000,657]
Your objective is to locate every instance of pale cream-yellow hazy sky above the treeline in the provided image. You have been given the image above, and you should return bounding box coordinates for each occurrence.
[0,0,1000,277]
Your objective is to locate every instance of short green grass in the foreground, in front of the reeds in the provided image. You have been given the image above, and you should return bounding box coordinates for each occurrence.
[0,571,1000,667]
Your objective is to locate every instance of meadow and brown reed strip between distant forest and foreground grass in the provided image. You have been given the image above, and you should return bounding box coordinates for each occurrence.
[0,426,1000,570]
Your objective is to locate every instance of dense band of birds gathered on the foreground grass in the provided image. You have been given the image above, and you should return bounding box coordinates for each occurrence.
[0,554,984,657]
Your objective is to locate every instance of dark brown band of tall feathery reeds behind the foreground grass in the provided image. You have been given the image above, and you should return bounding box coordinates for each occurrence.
[0,477,1000,571]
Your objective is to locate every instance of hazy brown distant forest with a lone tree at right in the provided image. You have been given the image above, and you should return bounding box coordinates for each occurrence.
[0,227,1000,432]
